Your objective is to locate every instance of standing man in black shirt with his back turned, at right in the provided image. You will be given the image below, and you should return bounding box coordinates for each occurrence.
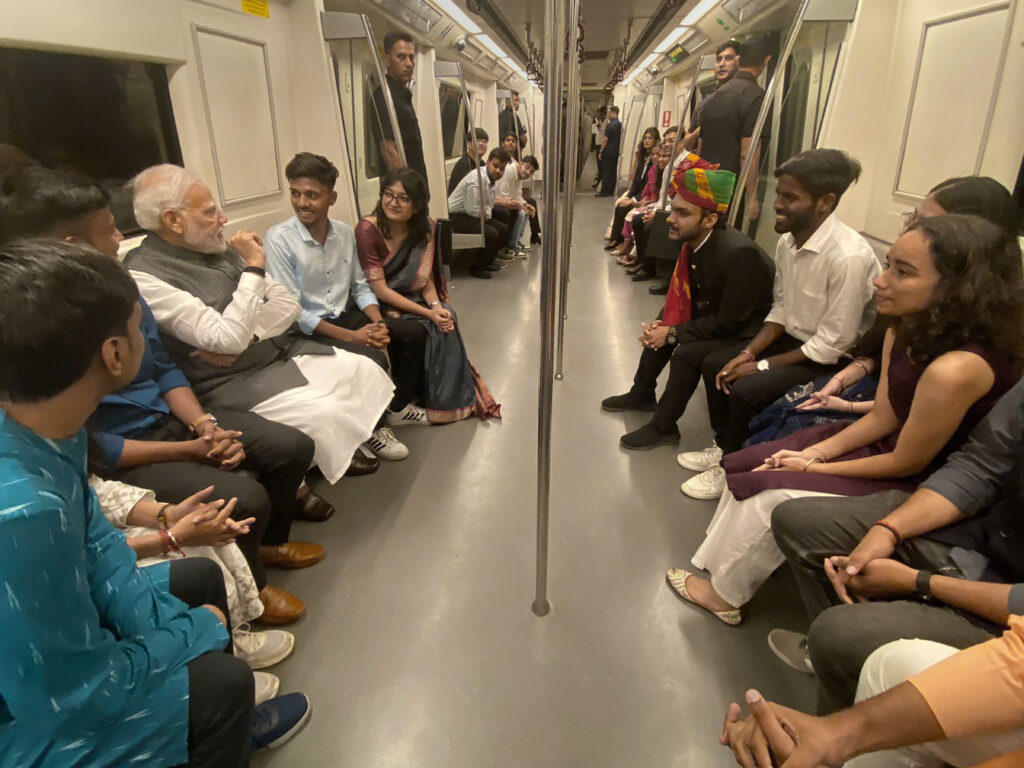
[687,35,771,221]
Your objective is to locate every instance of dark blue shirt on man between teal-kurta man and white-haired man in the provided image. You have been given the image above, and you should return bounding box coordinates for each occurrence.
[88,298,190,466]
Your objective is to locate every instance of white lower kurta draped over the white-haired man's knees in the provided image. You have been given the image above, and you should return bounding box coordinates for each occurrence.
[252,349,394,483]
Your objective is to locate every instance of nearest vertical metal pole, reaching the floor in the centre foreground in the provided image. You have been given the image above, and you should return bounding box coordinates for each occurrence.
[534,0,565,616]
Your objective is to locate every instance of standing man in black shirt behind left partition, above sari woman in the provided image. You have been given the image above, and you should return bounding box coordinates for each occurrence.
[374,32,427,191]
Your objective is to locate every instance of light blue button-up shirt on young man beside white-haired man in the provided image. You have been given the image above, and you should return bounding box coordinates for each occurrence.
[263,216,378,334]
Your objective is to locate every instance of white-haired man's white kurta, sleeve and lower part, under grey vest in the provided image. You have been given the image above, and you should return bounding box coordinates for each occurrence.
[132,271,394,483]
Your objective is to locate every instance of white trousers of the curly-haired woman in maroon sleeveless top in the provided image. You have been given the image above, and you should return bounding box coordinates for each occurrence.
[693,488,835,608]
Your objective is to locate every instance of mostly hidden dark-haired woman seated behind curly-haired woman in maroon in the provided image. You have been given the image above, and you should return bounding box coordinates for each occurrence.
[744,176,1017,447]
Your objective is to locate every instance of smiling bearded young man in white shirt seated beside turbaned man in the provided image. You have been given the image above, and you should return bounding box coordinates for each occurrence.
[678,150,882,499]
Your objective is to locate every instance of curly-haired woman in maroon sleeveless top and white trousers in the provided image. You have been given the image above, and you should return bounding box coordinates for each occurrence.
[668,215,1024,625]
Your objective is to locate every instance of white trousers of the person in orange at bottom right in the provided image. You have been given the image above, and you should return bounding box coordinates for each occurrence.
[846,640,1024,768]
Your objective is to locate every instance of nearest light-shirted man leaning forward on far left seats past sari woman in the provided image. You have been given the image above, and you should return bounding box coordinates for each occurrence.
[449,146,511,280]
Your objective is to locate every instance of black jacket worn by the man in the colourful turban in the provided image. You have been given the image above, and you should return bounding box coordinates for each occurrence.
[676,226,775,343]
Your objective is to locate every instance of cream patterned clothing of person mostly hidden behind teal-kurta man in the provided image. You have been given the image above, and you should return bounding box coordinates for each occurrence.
[89,475,263,627]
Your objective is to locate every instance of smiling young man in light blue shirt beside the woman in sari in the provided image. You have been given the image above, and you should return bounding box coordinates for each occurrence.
[263,152,427,461]
